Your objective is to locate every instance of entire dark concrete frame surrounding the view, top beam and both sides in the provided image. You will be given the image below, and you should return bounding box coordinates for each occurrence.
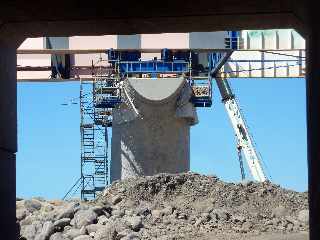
[0,0,320,240]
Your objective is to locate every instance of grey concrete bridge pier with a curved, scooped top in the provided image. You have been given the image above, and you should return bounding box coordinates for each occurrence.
[111,78,198,181]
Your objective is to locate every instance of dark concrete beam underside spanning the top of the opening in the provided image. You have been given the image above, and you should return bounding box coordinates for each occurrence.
[0,0,306,45]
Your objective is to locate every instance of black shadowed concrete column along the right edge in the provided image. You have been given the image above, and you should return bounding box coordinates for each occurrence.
[306,10,320,240]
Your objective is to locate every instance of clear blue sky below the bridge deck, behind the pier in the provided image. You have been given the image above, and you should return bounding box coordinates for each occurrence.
[17,79,307,199]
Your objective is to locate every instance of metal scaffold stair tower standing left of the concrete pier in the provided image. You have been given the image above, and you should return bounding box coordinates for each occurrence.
[80,66,119,200]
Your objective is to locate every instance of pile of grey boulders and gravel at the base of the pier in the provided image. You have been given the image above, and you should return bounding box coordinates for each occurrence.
[17,173,308,240]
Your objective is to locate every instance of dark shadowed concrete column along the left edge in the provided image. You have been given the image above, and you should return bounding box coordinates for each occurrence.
[0,40,17,239]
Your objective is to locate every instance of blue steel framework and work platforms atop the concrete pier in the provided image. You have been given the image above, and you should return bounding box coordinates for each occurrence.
[106,49,212,107]
